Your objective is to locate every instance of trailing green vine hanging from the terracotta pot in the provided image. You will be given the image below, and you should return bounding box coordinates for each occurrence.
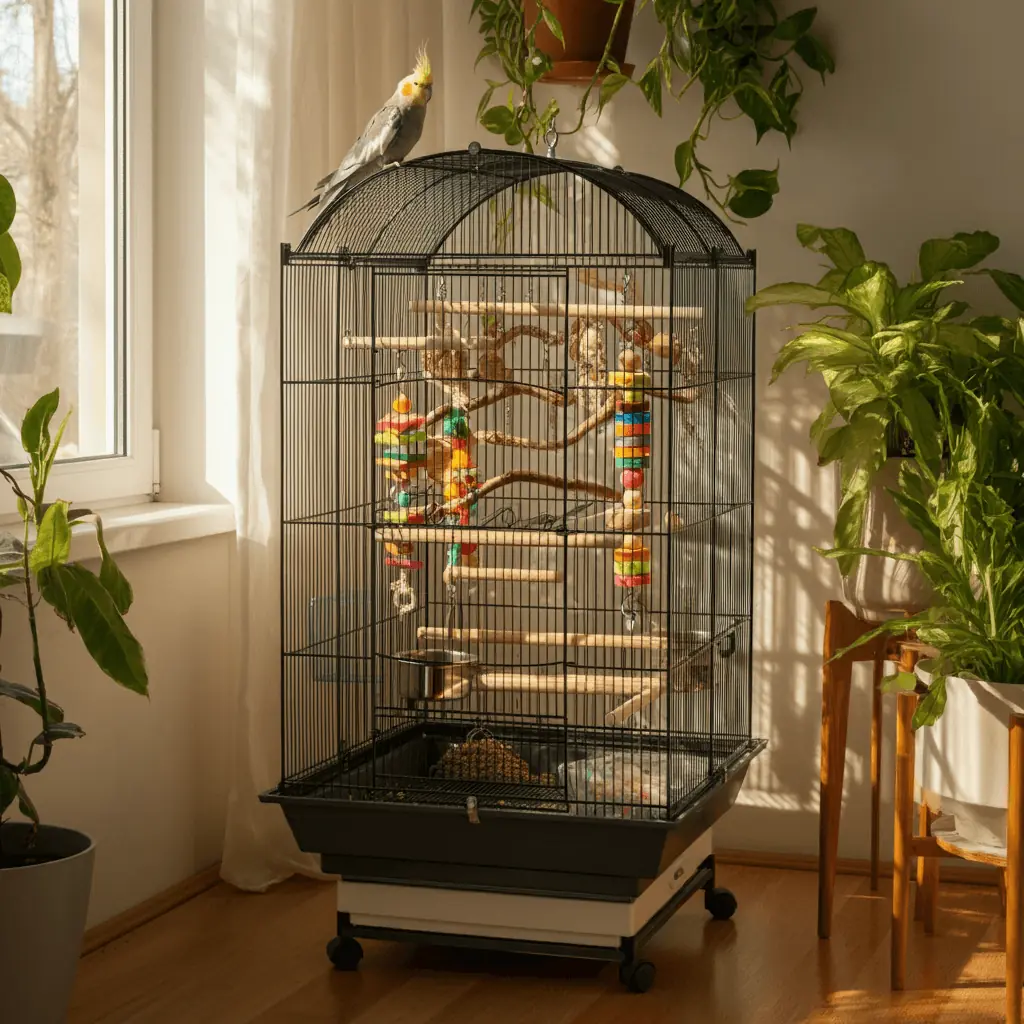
[470,0,835,217]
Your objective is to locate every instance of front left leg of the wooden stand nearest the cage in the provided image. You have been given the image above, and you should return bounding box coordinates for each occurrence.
[818,602,853,939]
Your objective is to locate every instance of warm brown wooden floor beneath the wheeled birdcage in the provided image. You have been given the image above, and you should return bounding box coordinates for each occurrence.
[70,866,1004,1024]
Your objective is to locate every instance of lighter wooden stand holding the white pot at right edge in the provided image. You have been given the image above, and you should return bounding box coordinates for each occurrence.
[892,693,1024,1024]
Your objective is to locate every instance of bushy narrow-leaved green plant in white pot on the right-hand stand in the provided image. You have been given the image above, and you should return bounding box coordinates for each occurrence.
[826,317,1024,849]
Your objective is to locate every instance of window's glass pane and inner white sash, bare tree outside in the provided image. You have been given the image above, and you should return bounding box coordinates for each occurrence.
[0,0,118,464]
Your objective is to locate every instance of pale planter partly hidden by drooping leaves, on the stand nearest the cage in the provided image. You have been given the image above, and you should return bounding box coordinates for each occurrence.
[836,459,932,622]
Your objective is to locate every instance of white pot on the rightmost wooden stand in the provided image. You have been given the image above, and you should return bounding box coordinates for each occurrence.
[915,669,1024,850]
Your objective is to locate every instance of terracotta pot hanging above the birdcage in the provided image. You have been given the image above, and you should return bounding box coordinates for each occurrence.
[523,0,634,83]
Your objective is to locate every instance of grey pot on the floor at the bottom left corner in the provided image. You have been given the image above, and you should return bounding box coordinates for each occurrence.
[0,822,95,1024]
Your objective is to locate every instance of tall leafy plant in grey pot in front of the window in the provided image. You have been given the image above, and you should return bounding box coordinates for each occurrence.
[0,178,148,1024]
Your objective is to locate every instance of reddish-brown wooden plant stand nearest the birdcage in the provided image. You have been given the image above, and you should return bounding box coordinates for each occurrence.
[818,601,918,939]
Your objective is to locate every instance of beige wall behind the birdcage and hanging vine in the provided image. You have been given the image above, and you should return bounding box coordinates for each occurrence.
[444,0,1024,856]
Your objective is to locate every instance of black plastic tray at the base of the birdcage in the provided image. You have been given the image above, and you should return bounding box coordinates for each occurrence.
[261,726,765,899]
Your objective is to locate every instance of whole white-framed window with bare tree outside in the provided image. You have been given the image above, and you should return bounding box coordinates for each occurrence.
[0,0,153,503]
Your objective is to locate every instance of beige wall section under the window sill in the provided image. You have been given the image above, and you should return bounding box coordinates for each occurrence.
[3,535,234,925]
